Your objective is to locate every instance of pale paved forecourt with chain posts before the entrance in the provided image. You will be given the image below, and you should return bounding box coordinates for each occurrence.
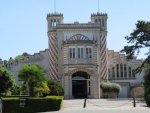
[39,99,150,113]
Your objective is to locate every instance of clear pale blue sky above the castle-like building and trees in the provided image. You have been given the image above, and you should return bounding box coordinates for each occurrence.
[0,0,150,60]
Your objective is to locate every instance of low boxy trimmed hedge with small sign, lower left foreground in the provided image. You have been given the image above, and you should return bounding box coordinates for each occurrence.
[3,97,63,113]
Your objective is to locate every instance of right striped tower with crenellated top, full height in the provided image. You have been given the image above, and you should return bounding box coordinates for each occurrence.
[91,12,108,80]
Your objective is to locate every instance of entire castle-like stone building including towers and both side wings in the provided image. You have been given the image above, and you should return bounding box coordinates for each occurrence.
[9,13,143,99]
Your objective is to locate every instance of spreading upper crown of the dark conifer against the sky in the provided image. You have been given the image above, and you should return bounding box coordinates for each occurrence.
[121,21,150,72]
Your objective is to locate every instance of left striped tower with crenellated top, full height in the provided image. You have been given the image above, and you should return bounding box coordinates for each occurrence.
[47,13,63,80]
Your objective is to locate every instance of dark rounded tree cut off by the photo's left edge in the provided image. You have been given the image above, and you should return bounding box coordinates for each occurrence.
[0,65,16,95]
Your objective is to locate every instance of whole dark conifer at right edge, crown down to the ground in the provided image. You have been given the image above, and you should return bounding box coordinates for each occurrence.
[121,21,150,106]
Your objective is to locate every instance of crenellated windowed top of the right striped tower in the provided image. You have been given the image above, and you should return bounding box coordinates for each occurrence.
[91,12,107,31]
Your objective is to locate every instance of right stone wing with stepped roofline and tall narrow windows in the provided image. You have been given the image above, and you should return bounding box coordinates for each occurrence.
[108,50,144,98]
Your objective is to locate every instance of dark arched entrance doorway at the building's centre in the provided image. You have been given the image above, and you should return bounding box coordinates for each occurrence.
[72,71,90,98]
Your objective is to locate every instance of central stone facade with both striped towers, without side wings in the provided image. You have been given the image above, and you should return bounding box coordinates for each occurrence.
[47,13,107,99]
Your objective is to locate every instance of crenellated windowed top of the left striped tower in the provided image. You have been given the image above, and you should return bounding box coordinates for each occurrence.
[47,13,63,31]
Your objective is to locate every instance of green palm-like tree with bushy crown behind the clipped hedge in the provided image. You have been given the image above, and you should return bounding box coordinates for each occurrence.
[18,64,46,96]
